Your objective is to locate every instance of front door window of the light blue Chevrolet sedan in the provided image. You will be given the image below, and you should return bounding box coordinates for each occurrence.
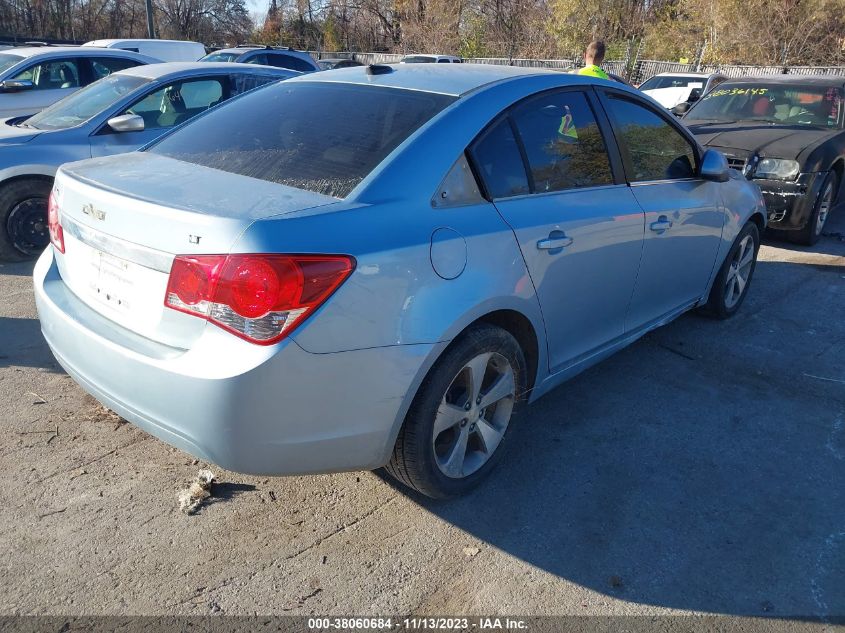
[608,96,696,182]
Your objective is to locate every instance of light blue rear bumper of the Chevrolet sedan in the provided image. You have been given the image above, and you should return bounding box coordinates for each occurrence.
[34,248,433,475]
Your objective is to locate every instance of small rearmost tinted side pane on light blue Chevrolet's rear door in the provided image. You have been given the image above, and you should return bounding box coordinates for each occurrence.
[471,118,529,198]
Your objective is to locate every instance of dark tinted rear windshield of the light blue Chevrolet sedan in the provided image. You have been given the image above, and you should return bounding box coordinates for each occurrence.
[149,82,456,198]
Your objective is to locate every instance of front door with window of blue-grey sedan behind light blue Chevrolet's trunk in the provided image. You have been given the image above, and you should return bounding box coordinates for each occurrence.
[90,75,229,157]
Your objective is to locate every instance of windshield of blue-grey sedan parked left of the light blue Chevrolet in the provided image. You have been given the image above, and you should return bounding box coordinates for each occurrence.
[25,75,150,130]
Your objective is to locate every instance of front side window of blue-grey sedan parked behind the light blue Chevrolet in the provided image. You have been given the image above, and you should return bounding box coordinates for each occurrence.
[124,79,224,130]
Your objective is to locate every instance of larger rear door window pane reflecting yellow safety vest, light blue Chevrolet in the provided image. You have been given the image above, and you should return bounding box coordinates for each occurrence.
[512,91,613,193]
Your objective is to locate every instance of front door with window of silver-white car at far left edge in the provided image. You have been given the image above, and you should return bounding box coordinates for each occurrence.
[0,58,82,118]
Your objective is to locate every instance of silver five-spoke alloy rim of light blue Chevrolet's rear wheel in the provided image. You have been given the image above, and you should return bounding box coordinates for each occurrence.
[432,352,516,479]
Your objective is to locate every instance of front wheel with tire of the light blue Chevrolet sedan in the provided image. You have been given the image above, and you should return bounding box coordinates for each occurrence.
[704,221,760,319]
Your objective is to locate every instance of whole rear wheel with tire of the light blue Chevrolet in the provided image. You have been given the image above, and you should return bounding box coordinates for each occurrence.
[385,324,526,499]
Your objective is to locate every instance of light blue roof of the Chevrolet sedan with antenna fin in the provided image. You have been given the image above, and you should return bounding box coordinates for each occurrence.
[293,64,576,96]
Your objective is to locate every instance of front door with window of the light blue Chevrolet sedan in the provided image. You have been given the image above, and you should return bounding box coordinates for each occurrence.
[600,89,725,330]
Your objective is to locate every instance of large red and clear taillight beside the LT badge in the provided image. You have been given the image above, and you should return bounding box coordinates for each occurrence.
[164,255,355,345]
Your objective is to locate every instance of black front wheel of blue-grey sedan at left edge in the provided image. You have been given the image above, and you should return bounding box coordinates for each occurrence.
[0,178,52,262]
